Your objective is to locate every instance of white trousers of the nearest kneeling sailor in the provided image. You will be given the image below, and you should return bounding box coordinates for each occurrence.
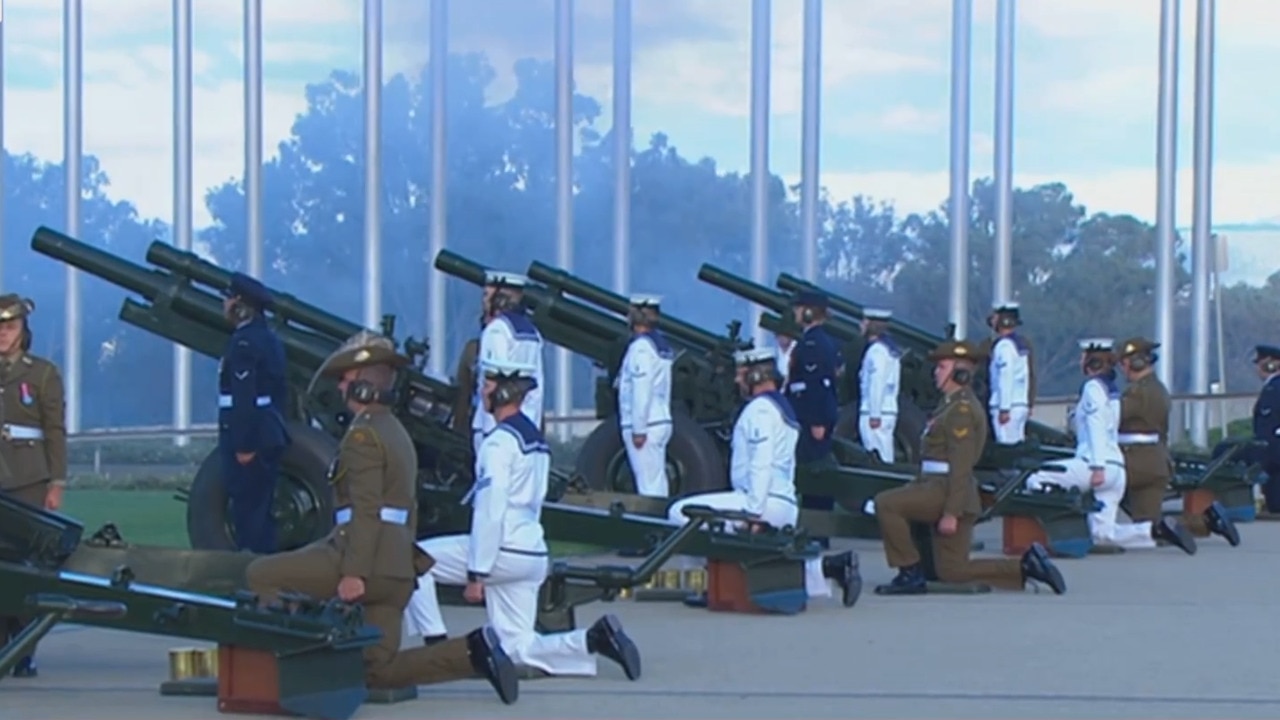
[404,536,596,675]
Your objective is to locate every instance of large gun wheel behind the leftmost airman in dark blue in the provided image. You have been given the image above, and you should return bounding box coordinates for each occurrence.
[187,423,337,551]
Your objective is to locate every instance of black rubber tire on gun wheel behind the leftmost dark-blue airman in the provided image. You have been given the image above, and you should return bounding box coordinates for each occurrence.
[187,423,338,551]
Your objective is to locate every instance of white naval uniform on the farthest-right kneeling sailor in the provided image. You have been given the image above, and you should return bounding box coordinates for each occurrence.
[1027,377,1156,547]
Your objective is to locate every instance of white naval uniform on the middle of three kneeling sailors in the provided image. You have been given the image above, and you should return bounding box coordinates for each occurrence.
[667,391,831,597]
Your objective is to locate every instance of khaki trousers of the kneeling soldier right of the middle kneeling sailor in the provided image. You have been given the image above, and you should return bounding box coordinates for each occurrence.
[876,482,1024,589]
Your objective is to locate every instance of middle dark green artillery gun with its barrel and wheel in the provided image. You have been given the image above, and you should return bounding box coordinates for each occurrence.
[435,250,750,497]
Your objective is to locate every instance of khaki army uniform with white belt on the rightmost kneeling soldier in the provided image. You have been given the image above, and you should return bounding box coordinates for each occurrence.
[1119,373,1172,525]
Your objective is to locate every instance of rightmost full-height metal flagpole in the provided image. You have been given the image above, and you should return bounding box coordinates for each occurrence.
[1192,0,1215,447]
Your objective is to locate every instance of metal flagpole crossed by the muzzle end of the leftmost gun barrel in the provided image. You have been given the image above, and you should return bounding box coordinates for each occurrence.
[63,0,84,433]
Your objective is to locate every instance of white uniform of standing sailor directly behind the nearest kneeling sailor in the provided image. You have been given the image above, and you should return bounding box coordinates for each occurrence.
[471,311,547,457]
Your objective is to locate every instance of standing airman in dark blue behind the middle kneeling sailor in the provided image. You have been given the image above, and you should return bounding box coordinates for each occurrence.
[787,292,844,464]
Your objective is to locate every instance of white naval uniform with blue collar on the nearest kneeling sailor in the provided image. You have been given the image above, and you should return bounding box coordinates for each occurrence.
[404,414,596,675]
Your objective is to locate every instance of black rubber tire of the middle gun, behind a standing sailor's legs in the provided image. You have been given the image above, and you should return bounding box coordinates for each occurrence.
[575,411,728,498]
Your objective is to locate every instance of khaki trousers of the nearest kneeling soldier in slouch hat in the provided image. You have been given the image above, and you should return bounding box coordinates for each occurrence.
[246,541,476,688]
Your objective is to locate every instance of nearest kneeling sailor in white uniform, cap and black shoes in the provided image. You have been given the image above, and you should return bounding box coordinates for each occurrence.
[406,360,640,680]
